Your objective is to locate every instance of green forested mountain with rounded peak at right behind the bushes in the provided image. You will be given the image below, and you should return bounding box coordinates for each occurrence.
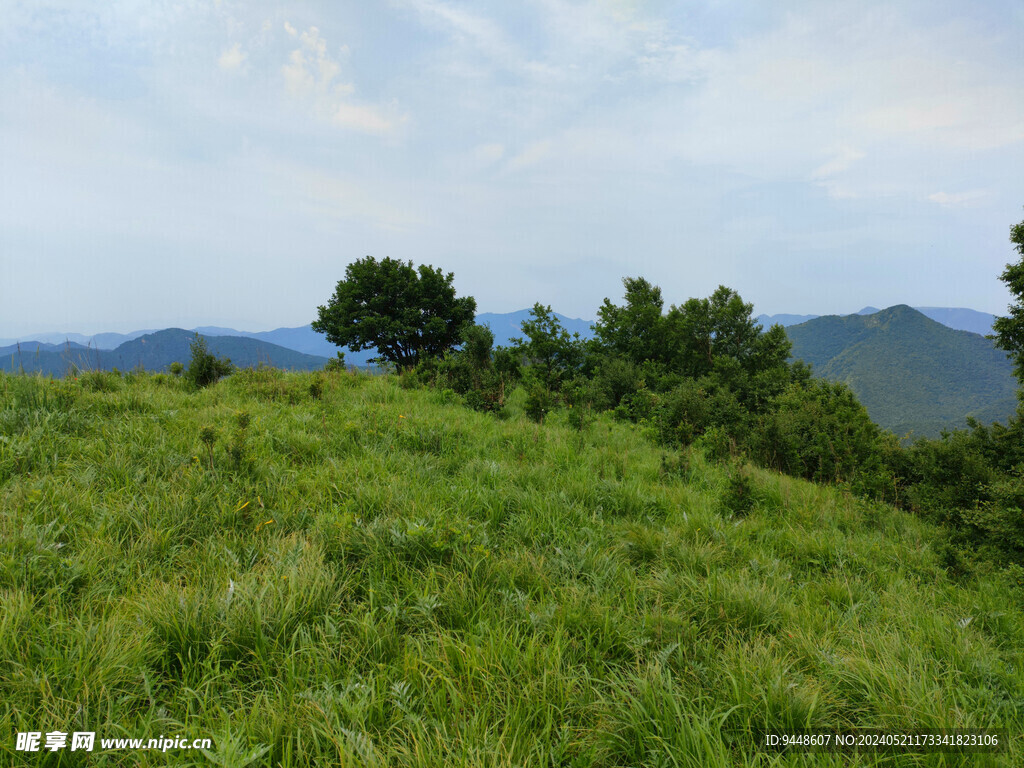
[786,304,1017,437]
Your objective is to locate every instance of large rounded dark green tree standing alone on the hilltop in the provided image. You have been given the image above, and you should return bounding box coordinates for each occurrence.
[312,256,476,369]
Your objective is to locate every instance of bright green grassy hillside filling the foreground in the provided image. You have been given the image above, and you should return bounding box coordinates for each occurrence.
[0,370,1024,767]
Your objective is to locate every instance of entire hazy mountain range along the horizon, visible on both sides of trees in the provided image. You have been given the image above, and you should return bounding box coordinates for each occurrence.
[6,305,1017,436]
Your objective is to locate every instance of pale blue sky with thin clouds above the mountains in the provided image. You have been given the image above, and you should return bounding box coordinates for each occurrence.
[0,0,1024,337]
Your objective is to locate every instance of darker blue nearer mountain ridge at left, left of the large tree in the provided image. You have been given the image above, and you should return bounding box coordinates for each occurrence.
[0,328,327,376]
